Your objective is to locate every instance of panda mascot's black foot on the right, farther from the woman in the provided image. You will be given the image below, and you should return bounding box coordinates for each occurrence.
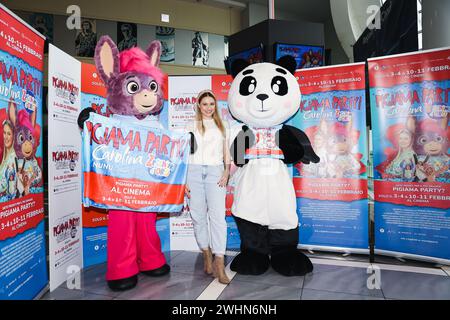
[271,248,313,277]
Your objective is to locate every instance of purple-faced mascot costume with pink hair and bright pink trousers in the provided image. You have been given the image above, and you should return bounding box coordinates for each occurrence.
[78,36,170,291]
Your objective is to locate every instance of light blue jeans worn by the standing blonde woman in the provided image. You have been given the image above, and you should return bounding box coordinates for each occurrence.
[187,164,227,255]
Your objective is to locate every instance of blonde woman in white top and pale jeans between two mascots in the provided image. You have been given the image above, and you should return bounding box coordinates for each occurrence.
[186,90,231,284]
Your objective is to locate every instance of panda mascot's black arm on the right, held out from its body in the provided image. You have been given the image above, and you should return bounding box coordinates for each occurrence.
[276,125,320,164]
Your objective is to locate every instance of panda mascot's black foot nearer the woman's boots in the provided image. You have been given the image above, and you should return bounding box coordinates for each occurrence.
[230,250,270,276]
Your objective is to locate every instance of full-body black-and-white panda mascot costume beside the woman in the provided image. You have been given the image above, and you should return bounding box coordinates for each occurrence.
[228,56,320,276]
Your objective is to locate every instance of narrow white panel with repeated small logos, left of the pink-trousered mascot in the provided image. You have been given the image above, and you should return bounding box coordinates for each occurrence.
[48,44,83,291]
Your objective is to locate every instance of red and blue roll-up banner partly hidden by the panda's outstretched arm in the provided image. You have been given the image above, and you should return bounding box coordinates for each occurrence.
[291,64,369,253]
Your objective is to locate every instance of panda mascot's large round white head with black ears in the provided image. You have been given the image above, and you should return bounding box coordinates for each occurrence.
[228,56,301,127]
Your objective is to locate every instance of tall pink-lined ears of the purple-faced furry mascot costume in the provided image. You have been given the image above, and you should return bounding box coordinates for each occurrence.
[94,36,161,83]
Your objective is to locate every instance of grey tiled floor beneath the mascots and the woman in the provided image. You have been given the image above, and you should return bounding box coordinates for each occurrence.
[43,251,450,300]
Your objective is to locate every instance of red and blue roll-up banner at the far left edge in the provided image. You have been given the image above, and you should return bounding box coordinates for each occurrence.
[0,4,48,300]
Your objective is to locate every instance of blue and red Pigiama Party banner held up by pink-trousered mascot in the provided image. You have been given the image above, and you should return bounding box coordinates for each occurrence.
[83,113,190,212]
